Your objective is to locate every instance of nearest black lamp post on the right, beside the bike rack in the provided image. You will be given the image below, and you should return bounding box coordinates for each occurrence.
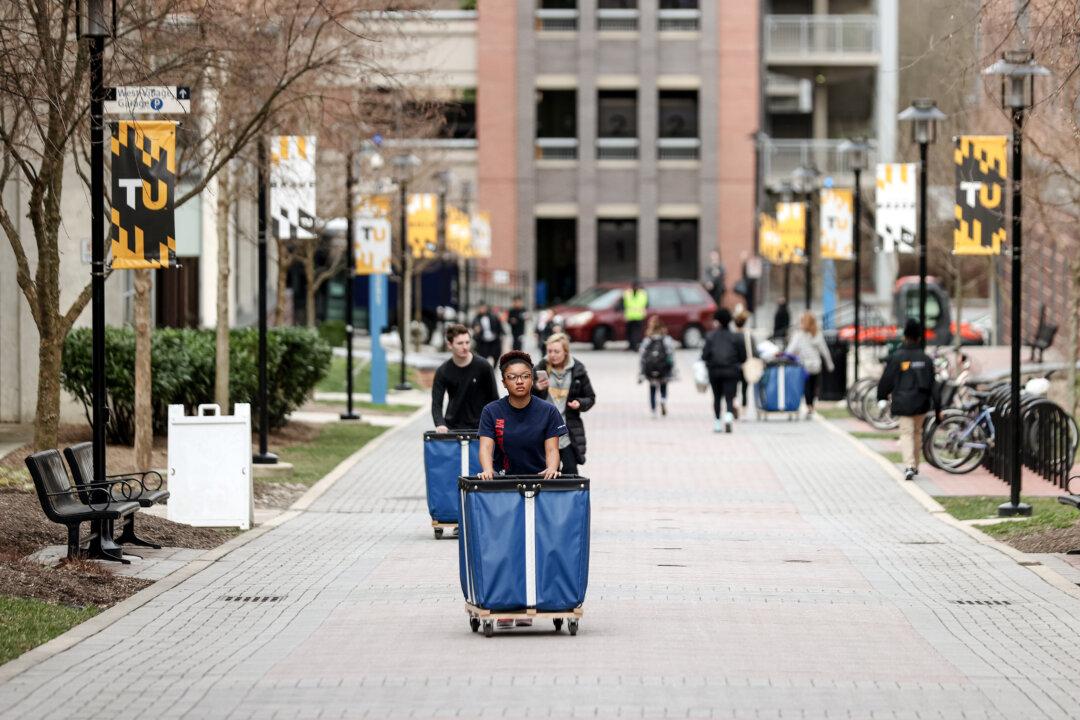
[983,50,1050,517]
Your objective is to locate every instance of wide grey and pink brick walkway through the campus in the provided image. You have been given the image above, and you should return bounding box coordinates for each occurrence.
[0,352,1080,719]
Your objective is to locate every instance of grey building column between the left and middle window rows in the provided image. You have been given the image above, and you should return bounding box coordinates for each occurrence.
[578,3,597,290]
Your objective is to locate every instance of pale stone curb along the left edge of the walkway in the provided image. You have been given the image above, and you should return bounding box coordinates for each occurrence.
[0,407,427,683]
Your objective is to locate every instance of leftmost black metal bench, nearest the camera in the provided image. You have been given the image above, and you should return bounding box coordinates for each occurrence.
[26,450,139,565]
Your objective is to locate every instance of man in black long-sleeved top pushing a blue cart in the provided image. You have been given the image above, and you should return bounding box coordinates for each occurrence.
[431,323,499,433]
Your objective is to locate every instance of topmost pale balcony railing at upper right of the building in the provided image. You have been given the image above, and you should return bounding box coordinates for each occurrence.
[765,15,880,65]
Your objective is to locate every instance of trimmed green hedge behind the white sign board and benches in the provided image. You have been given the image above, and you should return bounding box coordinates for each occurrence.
[60,327,332,445]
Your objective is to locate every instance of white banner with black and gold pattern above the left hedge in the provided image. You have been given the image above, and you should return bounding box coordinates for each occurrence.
[270,135,318,240]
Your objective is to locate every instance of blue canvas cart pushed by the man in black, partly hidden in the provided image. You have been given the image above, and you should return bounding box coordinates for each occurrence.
[423,430,481,540]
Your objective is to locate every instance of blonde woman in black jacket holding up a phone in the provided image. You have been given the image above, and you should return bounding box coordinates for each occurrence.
[532,332,596,475]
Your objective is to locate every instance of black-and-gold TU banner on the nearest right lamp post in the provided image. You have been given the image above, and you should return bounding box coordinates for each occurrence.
[953,135,1009,255]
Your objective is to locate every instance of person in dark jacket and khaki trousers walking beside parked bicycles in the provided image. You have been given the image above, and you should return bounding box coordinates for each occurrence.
[878,320,937,480]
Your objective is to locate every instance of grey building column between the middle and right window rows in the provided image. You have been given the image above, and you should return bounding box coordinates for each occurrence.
[637,0,660,280]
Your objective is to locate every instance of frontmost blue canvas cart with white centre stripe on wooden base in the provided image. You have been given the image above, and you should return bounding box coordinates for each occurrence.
[458,475,590,637]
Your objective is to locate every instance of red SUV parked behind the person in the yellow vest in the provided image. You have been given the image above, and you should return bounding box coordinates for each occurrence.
[538,280,716,350]
